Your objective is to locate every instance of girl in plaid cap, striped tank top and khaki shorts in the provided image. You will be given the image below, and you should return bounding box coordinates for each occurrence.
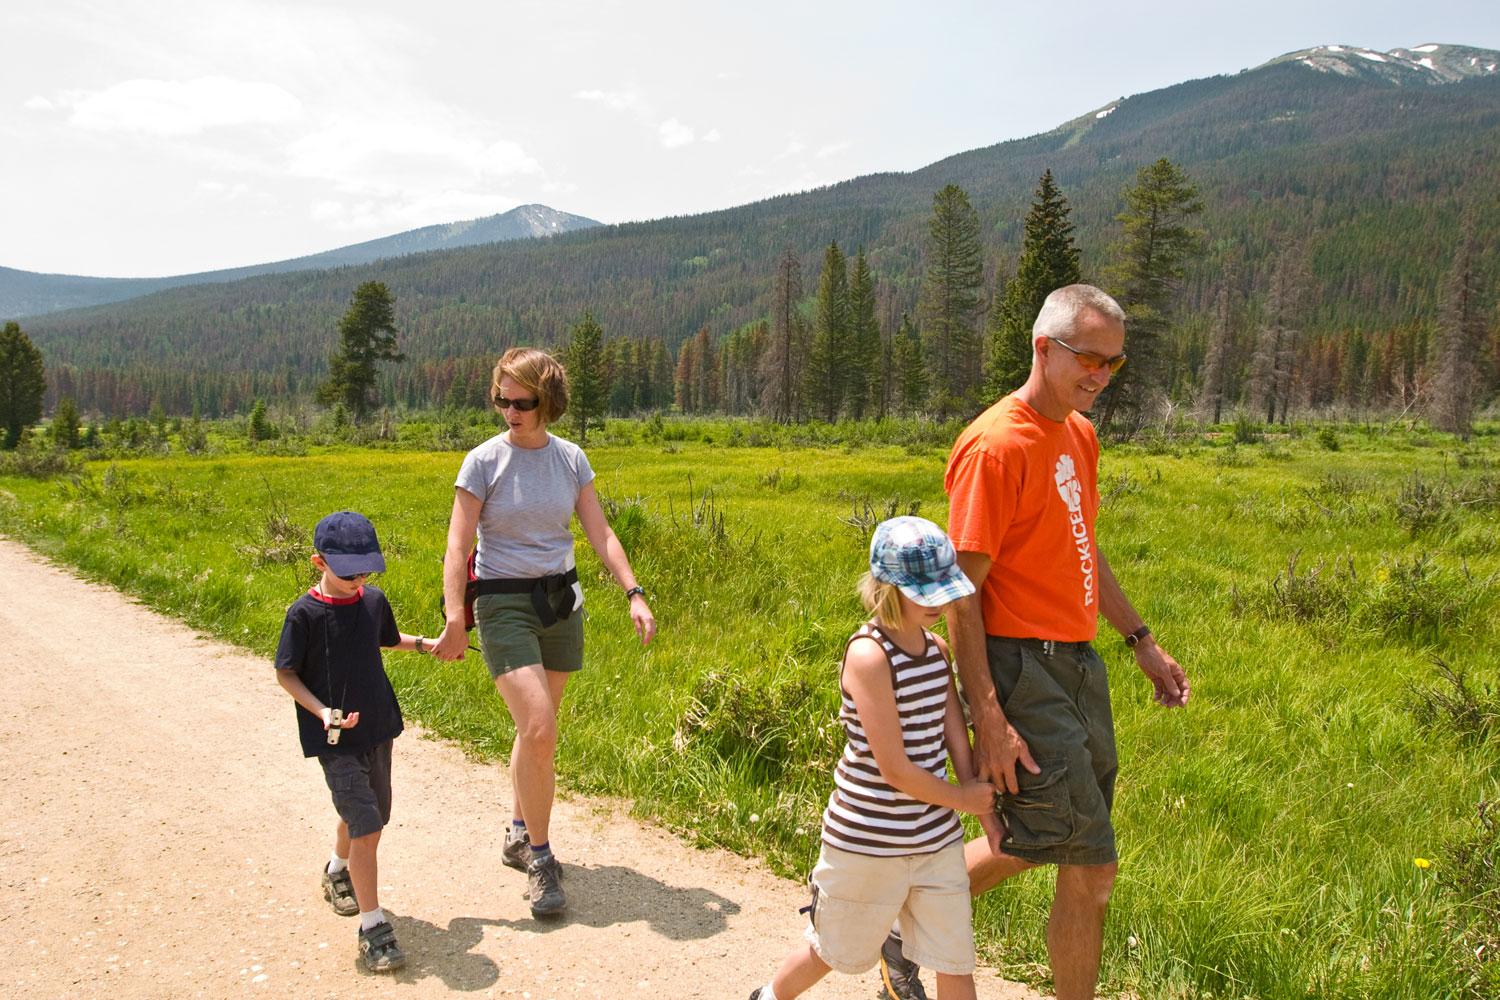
[750,517,995,1000]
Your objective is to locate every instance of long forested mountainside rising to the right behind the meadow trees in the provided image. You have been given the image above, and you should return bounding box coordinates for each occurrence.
[26,49,1500,414]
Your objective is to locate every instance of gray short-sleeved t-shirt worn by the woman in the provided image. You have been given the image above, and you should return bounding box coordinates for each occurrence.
[453,433,594,580]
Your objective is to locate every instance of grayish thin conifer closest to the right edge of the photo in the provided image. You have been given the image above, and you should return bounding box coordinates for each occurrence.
[1428,216,1487,441]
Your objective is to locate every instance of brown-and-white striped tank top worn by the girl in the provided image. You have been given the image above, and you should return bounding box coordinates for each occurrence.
[824,622,963,856]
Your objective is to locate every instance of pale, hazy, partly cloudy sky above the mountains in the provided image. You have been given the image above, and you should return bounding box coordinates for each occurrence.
[0,0,1500,276]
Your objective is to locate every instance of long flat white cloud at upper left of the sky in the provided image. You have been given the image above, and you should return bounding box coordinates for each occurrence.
[62,76,302,135]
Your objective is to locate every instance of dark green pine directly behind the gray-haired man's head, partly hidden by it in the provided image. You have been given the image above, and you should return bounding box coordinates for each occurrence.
[984,169,1082,399]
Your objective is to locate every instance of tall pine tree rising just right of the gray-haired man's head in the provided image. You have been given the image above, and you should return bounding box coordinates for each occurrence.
[1100,159,1203,426]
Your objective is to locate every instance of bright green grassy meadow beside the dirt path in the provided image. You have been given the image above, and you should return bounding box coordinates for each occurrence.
[0,421,1500,999]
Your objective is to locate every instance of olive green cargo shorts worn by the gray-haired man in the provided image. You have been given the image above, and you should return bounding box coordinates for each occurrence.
[987,636,1119,865]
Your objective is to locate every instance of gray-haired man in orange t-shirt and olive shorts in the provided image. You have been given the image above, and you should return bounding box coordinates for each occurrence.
[876,285,1188,1000]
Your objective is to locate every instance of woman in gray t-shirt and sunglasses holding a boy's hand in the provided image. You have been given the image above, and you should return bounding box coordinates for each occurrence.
[434,348,656,918]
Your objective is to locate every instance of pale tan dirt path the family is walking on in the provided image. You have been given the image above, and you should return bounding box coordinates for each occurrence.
[0,538,1037,1000]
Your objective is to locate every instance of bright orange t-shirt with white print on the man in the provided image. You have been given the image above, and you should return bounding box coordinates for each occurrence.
[944,396,1100,642]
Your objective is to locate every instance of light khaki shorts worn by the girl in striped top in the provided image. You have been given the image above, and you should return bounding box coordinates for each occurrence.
[807,841,974,976]
